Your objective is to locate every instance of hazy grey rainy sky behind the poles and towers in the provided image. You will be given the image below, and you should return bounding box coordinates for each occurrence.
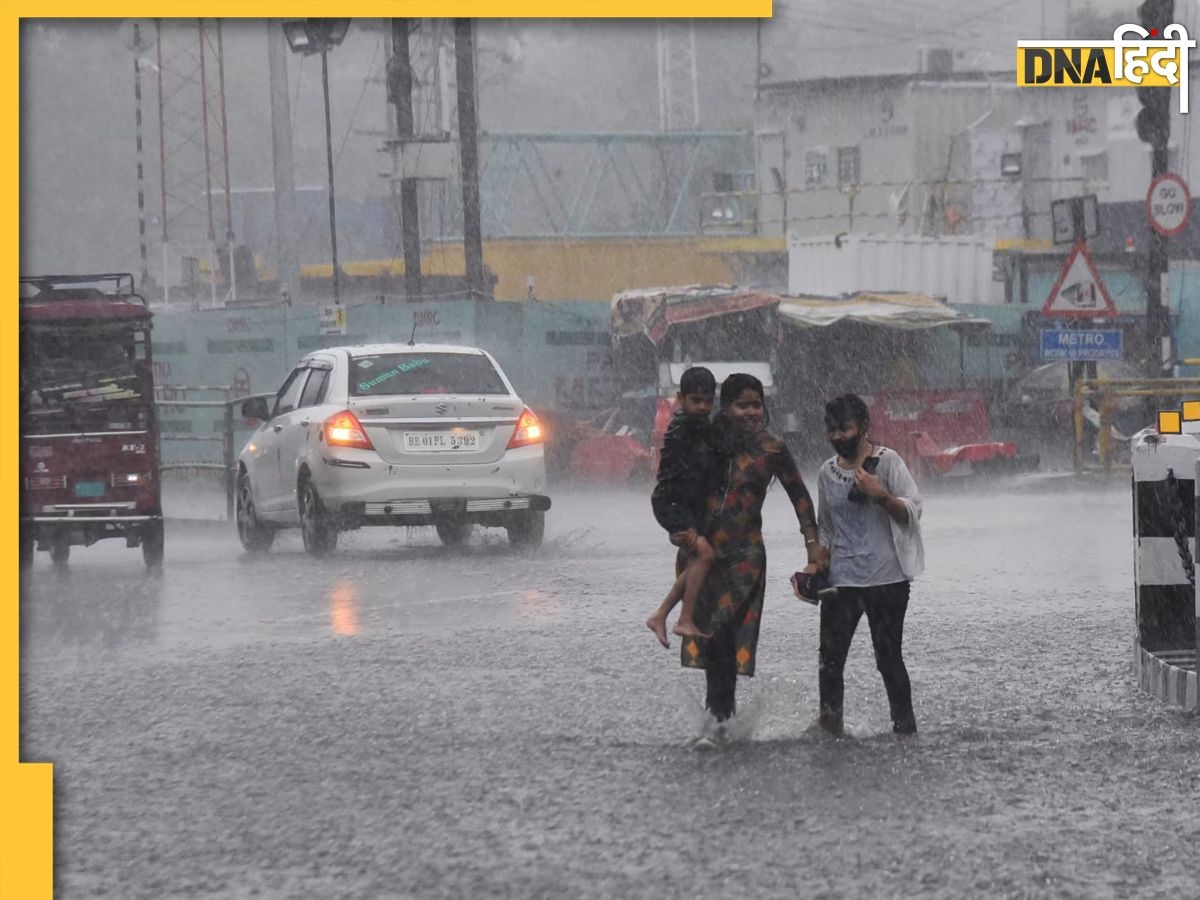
[20,0,1166,272]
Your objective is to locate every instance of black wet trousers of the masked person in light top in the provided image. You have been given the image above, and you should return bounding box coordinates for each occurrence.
[818,581,917,734]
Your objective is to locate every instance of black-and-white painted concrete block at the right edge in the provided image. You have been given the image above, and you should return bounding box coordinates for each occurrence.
[1132,428,1200,709]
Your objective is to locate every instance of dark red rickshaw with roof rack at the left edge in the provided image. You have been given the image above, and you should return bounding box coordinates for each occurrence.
[20,272,163,568]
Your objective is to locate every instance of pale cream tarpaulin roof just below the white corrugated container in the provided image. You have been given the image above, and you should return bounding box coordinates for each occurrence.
[779,292,991,329]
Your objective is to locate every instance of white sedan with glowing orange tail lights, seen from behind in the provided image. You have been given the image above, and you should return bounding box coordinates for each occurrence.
[236,343,550,554]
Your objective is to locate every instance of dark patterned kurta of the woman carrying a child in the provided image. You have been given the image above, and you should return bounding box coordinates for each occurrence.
[676,432,816,676]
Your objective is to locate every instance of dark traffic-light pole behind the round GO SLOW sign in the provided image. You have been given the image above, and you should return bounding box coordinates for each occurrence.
[1136,0,1171,378]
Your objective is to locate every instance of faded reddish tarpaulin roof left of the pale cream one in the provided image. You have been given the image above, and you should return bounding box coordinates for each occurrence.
[612,284,780,346]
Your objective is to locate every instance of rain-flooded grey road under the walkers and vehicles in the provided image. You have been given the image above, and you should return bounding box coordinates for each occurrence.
[22,480,1200,898]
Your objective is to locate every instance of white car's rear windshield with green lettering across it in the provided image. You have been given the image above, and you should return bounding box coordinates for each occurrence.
[350,353,509,397]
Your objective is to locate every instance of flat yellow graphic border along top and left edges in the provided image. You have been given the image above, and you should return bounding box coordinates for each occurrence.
[0,0,772,900]
